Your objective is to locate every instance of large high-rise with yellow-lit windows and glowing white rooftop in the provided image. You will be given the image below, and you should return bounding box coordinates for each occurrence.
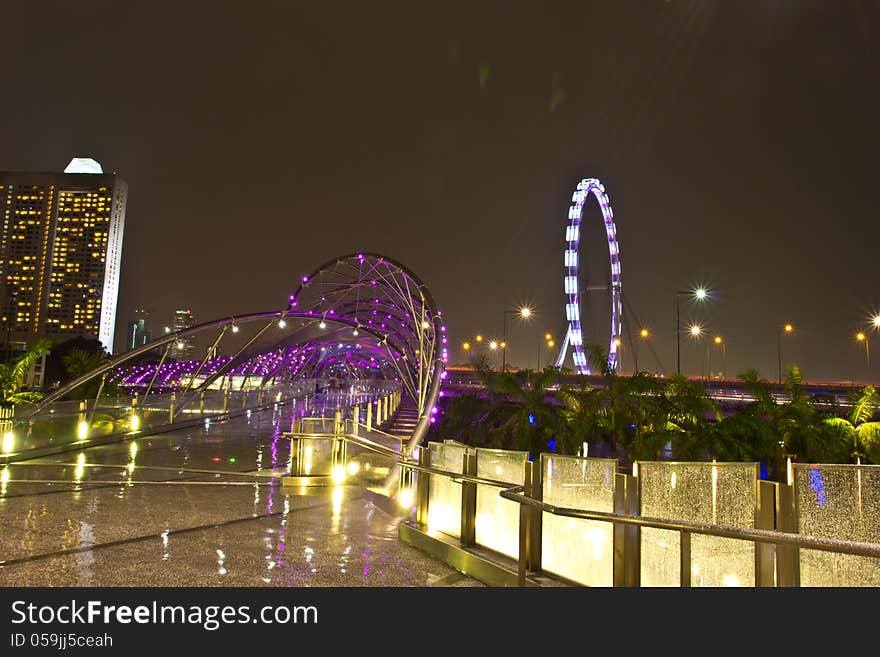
[0,158,128,353]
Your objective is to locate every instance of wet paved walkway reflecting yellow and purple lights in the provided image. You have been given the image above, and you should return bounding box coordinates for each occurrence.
[0,412,479,586]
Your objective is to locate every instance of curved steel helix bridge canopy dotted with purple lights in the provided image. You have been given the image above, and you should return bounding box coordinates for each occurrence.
[31,253,447,445]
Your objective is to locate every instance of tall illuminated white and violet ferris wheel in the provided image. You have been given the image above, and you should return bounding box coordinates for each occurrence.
[556,178,623,374]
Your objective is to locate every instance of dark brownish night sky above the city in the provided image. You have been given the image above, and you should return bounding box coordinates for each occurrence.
[0,0,880,380]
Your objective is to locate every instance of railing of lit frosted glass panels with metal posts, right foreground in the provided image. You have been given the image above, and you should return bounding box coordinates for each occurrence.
[400,443,880,587]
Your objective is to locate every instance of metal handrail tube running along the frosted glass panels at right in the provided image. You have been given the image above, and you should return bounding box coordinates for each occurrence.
[498,484,880,558]
